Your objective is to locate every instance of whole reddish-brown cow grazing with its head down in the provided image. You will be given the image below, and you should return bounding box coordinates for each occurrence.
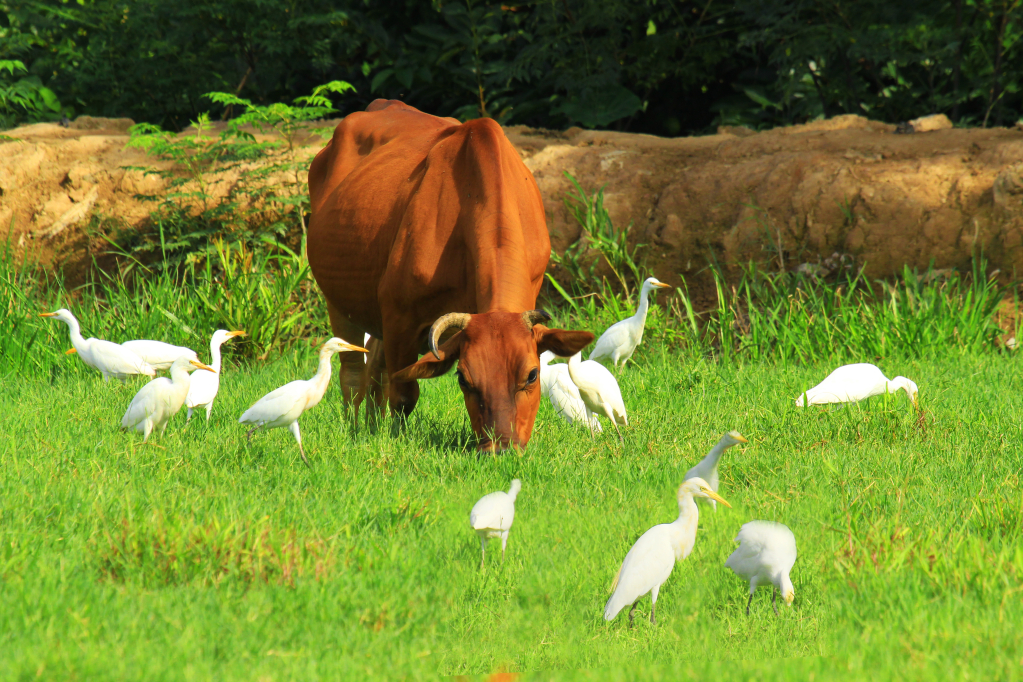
[308,99,593,449]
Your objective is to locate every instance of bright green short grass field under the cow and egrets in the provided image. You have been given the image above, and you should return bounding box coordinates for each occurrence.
[0,339,1023,680]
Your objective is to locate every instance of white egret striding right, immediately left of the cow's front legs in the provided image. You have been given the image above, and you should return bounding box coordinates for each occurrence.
[238,336,367,466]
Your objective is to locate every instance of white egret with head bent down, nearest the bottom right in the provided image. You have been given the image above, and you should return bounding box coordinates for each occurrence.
[724,521,796,616]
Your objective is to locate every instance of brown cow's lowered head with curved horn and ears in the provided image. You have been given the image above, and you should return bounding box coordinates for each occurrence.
[393,310,593,450]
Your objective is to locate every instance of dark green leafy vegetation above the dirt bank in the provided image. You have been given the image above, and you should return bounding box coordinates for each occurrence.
[0,0,1023,135]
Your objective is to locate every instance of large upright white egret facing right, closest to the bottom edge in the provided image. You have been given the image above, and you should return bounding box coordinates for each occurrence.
[604,479,731,627]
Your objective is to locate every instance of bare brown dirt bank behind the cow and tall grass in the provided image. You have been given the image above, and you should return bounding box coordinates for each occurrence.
[0,116,1023,300]
